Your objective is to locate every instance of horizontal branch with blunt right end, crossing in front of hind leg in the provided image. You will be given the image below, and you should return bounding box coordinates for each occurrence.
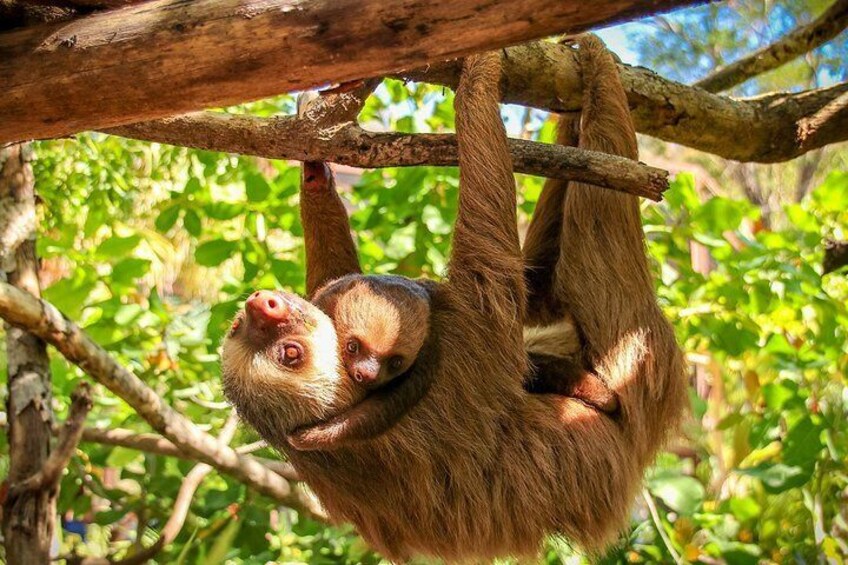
[107,112,668,200]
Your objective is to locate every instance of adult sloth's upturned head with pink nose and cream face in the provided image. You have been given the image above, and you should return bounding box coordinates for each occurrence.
[222,290,364,438]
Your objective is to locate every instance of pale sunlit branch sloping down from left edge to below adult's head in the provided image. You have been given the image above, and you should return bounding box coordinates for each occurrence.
[0,283,323,519]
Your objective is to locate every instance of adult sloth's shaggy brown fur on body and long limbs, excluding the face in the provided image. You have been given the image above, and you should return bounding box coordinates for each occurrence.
[224,37,685,560]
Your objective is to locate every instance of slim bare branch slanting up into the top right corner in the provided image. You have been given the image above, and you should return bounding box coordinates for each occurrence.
[694,0,848,92]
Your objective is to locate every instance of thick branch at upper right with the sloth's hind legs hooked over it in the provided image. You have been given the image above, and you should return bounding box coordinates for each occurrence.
[398,42,848,163]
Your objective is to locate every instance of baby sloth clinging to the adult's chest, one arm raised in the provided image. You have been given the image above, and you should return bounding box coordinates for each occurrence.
[289,158,618,450]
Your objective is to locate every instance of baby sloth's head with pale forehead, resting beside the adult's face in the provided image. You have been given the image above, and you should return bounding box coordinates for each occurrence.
[314,275,430,389]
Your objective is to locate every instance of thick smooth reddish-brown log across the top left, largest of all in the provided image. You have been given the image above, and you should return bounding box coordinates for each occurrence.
[0,0,698,143]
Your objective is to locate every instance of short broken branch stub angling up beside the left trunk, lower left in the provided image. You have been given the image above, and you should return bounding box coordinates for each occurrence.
[9,383,92,497]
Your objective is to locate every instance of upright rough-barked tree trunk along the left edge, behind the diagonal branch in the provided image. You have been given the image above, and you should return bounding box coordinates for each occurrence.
[0,145,56,563]
